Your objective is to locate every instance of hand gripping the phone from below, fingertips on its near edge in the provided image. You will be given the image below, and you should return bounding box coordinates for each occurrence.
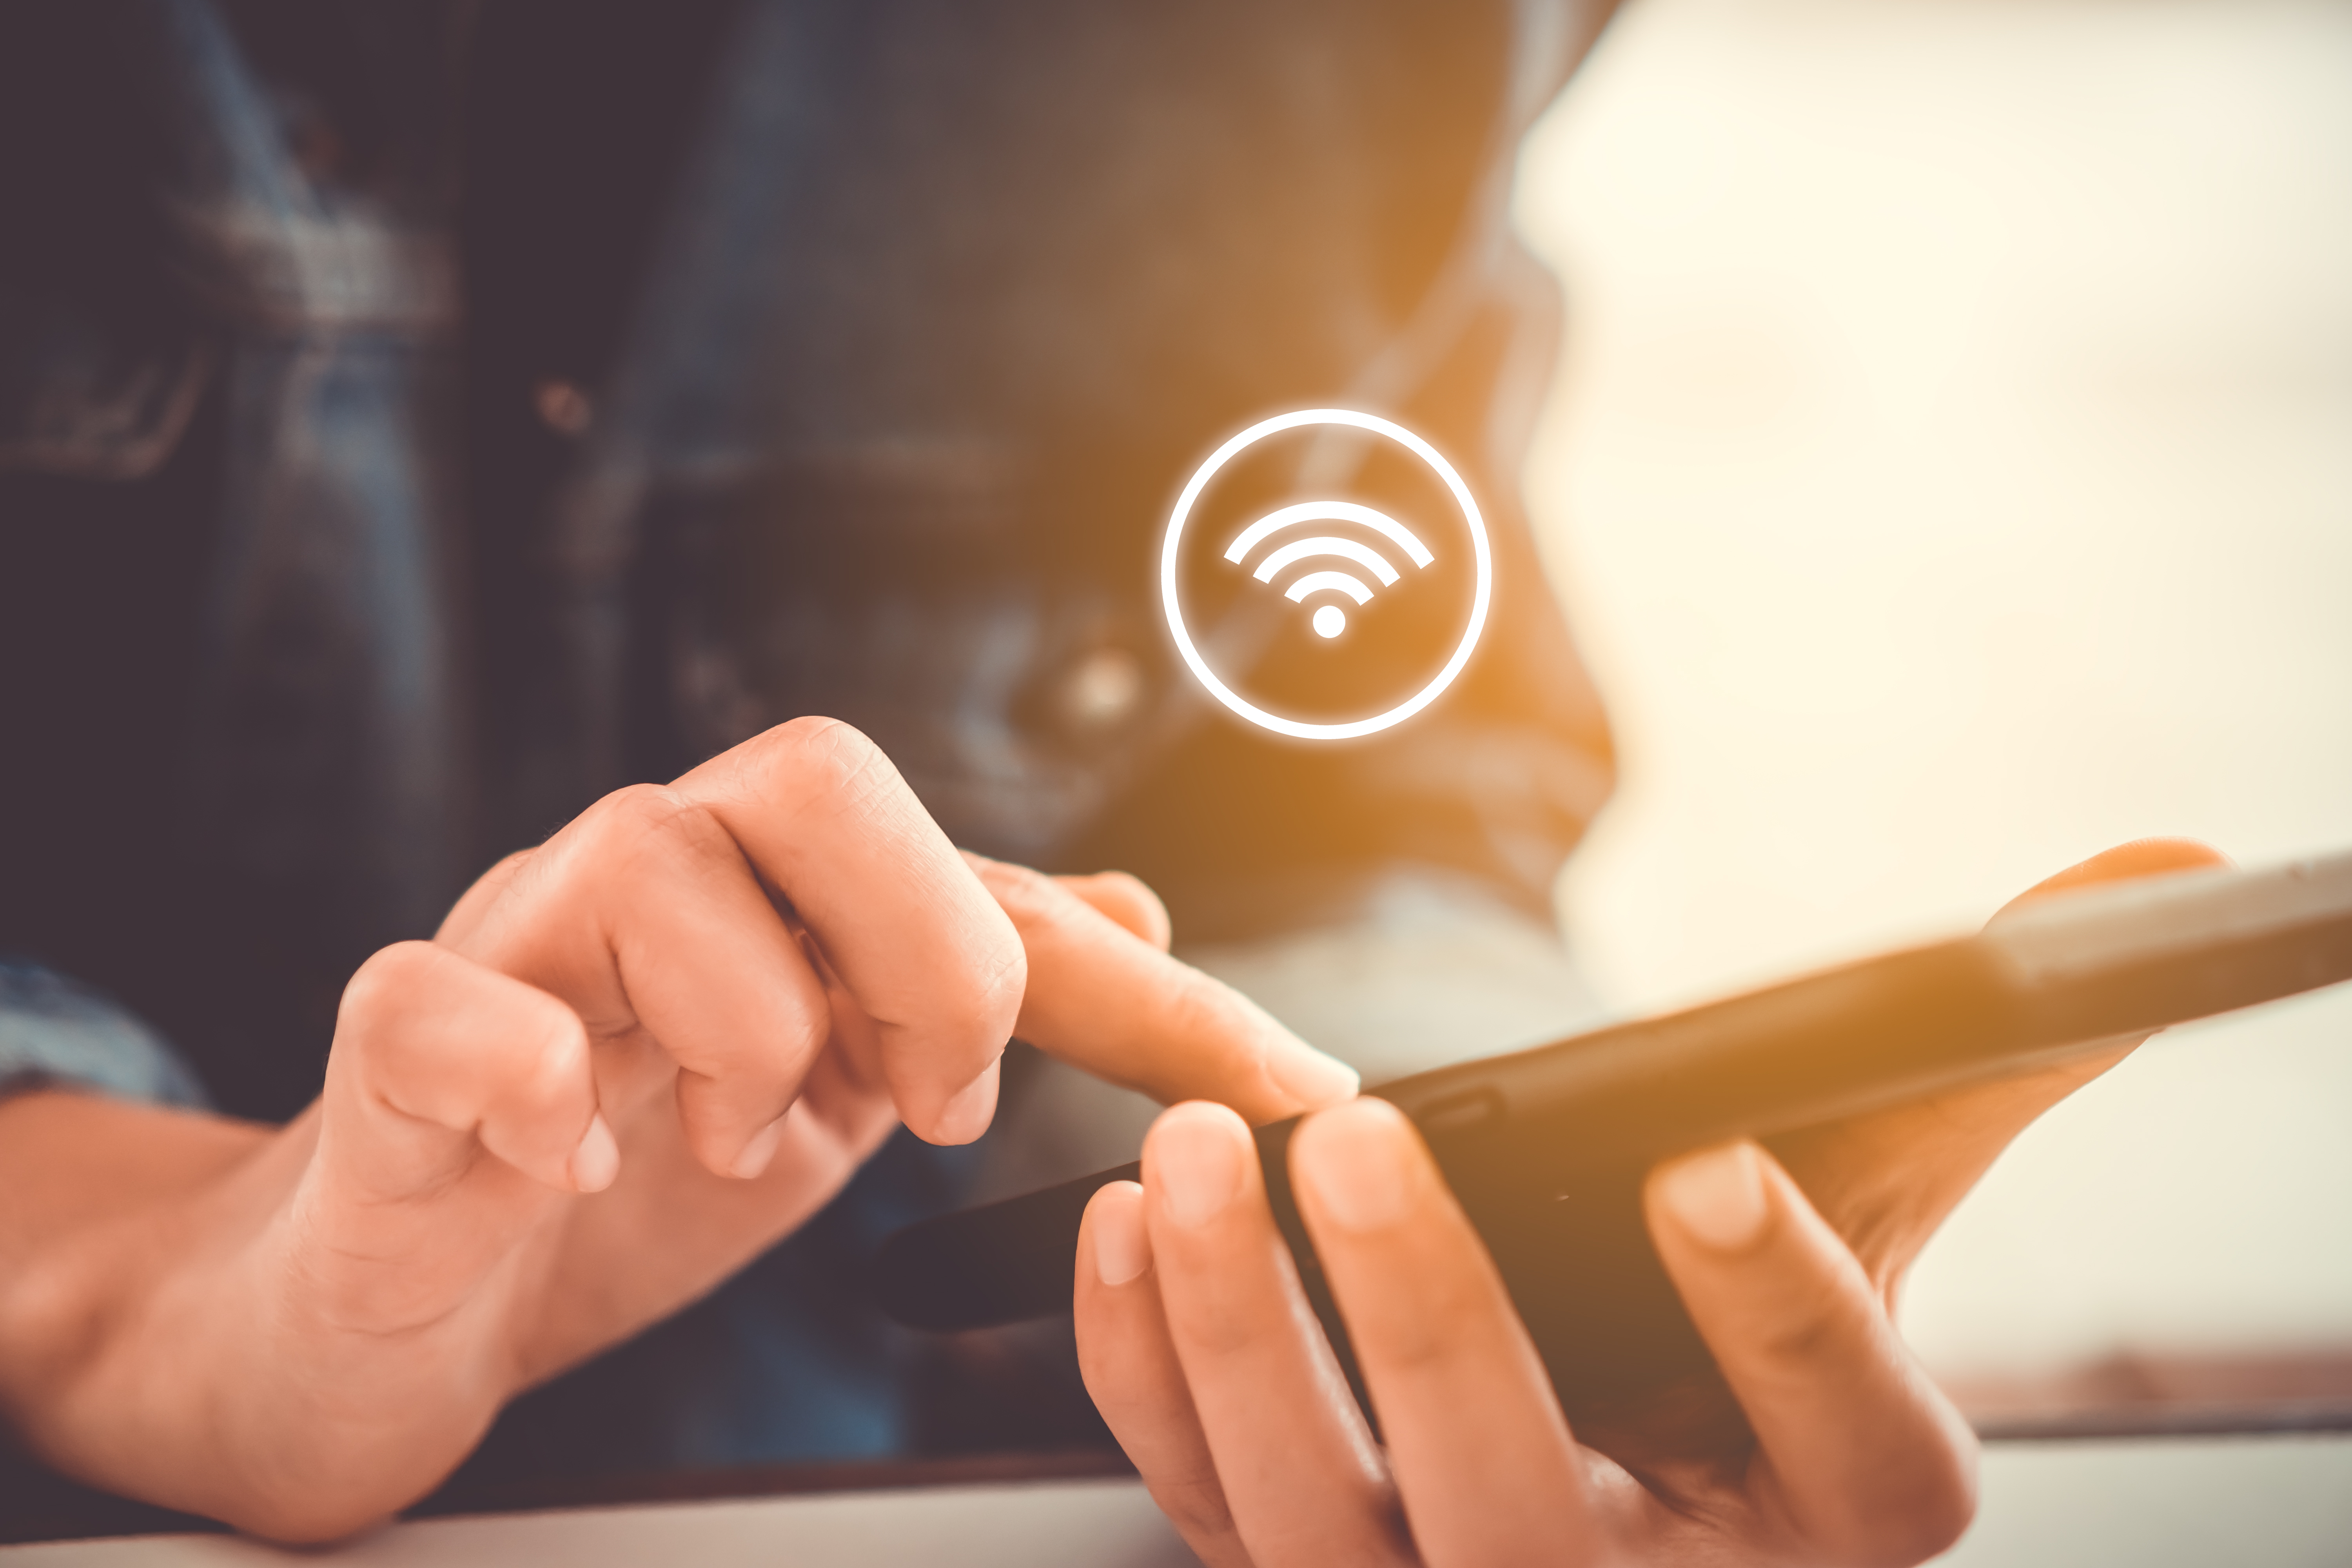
[1075,844,2218,1568]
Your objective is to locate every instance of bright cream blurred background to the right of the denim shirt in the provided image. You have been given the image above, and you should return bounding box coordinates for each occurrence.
[1517,0,2352,1420]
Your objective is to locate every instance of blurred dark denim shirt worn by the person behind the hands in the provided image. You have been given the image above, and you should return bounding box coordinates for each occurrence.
[0,0,1611,1474]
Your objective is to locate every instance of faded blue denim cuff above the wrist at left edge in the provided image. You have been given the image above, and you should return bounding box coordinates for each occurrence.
[0,955,209,1110]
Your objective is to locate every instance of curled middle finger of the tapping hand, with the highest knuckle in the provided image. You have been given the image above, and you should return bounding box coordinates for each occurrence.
[675,719,1028,1143]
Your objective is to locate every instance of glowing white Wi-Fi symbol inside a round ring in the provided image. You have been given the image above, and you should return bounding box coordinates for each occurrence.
[1160,409,1494,740]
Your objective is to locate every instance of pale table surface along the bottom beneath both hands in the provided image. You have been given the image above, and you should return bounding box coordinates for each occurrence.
[0,1434,2352,1568]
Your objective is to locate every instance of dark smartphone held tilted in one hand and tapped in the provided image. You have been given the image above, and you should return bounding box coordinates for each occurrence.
[870,851,2352,1422]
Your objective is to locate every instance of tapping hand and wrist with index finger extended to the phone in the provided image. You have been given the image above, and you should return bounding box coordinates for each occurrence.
[0,722,1355,1540]
